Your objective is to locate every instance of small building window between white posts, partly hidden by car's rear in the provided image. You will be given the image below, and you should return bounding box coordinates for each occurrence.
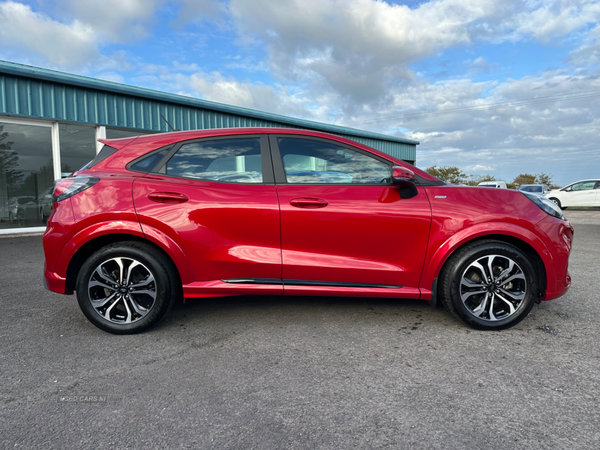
[58,123,96,177]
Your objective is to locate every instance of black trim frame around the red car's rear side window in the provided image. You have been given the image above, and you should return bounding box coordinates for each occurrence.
[146,134,275,186]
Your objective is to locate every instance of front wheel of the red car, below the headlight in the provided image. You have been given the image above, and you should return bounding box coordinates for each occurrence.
[439,240,538,330]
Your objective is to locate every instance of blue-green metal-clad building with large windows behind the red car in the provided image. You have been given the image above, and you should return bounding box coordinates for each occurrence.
[0,61,418,234]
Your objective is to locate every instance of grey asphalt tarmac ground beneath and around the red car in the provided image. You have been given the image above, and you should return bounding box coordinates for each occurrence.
[0,210,600,450]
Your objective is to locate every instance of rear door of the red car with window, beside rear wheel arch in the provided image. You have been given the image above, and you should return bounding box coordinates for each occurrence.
[133,135,282,295]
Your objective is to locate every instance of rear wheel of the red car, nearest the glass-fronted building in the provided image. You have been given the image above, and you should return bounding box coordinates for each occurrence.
[76,242,181,334]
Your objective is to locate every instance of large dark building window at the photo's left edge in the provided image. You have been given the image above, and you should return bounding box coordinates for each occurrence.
[0,121,54,229]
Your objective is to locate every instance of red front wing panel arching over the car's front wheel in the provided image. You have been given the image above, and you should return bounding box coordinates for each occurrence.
[420,185,573,299]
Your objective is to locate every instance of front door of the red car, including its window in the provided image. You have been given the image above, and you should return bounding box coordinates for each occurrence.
[271,135,431,297]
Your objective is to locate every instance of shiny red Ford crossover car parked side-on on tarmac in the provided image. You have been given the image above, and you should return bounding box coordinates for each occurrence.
[44,128,573,333]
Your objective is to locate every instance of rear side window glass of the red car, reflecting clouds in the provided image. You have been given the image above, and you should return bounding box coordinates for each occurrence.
[166,138,263,183]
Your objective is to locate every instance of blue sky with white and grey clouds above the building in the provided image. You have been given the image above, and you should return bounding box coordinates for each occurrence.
[0,0,600,185]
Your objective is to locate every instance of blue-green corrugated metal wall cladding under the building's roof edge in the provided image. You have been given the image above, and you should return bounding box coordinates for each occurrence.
[0,69,416,162]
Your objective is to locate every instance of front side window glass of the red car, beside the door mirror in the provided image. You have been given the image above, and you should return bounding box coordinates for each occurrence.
[277,137,390,184]
